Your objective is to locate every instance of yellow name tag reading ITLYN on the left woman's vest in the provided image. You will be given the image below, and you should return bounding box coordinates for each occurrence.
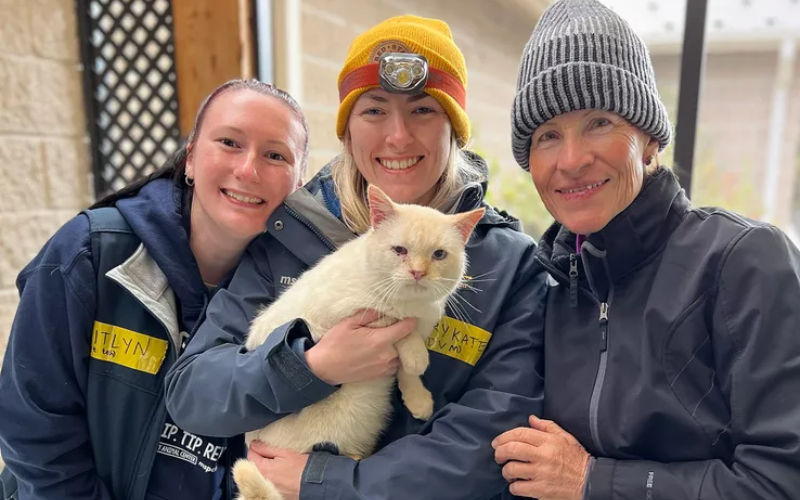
[92,321,168,375]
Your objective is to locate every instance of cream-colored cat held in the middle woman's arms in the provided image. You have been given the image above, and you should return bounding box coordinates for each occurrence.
[233,186,484,500]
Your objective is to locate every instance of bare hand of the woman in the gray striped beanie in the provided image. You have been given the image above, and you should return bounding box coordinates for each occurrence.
[492,415,590,500]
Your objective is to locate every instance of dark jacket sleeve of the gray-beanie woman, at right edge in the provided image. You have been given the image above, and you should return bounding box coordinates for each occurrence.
[587,226,800,500]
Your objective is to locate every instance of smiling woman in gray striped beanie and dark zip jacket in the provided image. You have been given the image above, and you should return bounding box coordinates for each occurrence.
[492,0,800,500]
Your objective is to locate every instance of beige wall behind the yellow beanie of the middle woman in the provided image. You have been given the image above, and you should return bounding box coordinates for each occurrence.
[294,0,535,178]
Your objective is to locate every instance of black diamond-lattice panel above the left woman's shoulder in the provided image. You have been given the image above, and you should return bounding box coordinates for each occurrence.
[75,0,181,199]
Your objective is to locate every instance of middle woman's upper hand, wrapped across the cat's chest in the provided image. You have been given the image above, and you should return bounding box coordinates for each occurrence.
[306,310,417,385]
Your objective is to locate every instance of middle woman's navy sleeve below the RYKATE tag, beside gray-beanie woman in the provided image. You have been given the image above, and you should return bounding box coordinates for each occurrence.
[300,245,546,500]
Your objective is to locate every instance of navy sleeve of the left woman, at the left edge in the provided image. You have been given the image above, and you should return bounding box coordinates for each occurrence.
[0,219,112,500]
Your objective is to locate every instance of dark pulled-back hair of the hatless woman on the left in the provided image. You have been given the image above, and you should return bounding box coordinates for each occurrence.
[89,79,309,208]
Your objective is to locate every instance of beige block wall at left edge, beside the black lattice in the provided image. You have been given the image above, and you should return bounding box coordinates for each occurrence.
[0,0,91,353]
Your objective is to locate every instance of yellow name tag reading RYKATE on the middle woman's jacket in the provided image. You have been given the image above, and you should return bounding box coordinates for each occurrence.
[428,316,492,366]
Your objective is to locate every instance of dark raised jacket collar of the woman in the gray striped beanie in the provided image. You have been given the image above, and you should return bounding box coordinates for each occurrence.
[536,168,689,281]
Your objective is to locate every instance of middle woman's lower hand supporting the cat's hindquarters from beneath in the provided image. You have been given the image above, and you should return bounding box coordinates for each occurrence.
[247,441,308,500]
